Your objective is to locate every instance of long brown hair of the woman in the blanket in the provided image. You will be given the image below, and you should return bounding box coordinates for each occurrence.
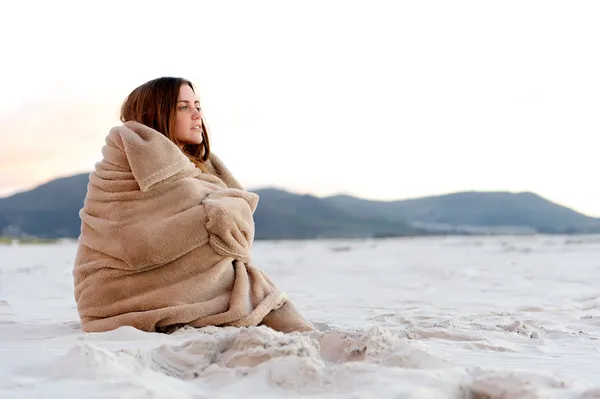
[120,77,210,171]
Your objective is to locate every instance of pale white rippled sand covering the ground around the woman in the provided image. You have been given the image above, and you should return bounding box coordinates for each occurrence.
[0,236,600,399]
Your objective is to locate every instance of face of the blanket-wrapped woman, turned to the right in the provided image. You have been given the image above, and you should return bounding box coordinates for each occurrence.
[173,84,202,146]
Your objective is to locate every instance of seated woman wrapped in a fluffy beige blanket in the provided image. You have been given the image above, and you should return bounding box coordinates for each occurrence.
[73,78,313,332]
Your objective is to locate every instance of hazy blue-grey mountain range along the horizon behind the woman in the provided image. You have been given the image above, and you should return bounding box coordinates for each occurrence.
[0,174,600,240]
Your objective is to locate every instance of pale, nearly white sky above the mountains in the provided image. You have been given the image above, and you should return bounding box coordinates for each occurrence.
[0,0,600,216]
